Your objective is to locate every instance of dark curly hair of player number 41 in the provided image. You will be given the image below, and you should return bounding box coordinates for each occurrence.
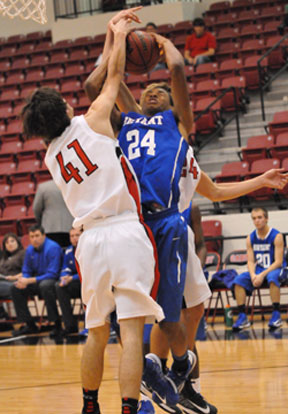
[21,88,71,145]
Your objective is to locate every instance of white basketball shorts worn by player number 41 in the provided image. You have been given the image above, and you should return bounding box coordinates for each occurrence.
[76,214,164,329]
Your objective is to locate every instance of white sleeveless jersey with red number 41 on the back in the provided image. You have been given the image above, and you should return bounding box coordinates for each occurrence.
[45,115,139,227]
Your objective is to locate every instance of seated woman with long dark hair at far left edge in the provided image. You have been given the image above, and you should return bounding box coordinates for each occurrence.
[0,233,25,317]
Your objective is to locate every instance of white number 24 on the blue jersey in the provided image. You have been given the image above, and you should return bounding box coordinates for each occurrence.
[126,129,156,160]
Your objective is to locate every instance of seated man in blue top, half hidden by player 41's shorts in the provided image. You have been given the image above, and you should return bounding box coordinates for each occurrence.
[56,228,81,335]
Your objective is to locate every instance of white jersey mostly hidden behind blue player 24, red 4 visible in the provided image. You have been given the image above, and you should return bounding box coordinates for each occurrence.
[178,146,201,213]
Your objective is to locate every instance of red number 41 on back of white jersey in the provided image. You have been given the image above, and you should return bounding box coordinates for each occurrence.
[56,139,98,184]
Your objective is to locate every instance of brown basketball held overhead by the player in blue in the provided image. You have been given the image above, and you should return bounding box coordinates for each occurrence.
[125,30,159,75]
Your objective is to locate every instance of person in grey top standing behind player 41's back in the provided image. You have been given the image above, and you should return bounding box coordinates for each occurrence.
[33,180,73,247]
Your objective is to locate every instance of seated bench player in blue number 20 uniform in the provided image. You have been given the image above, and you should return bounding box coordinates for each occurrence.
[233,207,286,331]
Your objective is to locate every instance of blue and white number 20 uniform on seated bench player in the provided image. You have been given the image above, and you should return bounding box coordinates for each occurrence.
[234,227,286,295]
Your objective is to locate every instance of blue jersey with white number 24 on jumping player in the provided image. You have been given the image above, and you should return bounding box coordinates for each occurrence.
[118,110,188,208]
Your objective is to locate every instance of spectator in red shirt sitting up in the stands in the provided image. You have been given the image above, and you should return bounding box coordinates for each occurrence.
[184,18,216,66]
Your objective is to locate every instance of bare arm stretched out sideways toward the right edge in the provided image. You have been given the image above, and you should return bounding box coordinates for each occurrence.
[196,169,288,201]
